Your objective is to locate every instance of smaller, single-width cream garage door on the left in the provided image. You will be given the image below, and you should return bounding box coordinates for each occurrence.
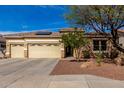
[11,44,24,58]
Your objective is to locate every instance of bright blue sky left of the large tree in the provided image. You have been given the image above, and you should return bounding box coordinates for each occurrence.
[0,5,69,33]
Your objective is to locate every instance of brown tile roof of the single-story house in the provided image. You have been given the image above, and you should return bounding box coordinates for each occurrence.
[4,28,115,39]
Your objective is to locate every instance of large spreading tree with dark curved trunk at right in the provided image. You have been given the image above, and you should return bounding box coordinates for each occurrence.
[66,5,124,53]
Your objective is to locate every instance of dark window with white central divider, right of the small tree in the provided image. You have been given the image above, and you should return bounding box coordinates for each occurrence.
[93,40,106,51]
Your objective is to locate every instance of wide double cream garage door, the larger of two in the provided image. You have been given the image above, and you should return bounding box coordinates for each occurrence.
[28,44,61,58]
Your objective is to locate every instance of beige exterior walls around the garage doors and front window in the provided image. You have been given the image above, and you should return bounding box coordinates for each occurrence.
[6,37,112,58]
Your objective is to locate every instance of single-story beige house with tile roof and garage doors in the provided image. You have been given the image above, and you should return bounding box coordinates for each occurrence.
[4,28,124,58]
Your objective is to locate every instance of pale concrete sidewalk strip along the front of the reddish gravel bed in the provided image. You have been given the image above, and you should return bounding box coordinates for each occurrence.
[48,75,124,88]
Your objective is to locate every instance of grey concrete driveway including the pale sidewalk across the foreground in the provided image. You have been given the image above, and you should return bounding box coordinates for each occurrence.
[0,59,124,88]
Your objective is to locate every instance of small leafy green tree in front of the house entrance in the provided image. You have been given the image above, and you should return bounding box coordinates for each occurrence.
[61,30,89,62]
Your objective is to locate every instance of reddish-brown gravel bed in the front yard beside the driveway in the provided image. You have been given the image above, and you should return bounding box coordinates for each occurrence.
[50,60,124,80]
